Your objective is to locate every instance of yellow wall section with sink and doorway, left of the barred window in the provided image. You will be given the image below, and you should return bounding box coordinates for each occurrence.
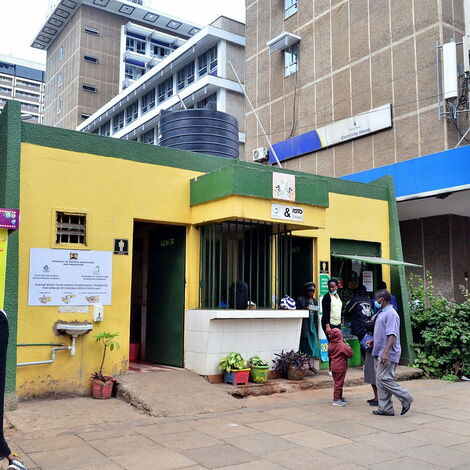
[17,144,201,396]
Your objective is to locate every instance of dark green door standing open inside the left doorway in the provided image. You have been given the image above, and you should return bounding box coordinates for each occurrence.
[145,226,186,367]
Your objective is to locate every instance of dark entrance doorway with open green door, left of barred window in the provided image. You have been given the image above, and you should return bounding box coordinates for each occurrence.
[130,222,186,367]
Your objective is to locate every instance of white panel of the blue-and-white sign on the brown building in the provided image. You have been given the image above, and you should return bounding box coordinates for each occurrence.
[317,104,392,148]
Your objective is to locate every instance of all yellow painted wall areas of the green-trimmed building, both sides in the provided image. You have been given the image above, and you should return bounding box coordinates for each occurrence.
[16,143,389,396]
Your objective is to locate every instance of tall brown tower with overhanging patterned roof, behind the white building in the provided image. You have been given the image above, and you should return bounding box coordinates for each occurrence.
[32,0,200,129]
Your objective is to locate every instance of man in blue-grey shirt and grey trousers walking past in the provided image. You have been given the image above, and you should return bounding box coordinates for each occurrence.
[372,289,413,416]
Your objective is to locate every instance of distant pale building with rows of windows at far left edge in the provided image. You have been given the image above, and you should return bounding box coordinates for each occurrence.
[0,55,46,123]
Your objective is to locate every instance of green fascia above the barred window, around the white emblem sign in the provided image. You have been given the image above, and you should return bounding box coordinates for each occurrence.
[191,162,328,207]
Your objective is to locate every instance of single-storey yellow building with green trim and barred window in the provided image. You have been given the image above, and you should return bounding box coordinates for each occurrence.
[0,102,412,397]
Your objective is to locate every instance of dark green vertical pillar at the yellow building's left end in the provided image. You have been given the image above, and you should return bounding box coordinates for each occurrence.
[0,101,21,393]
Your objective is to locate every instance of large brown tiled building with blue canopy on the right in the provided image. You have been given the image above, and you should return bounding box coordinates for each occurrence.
[245,0,470,299]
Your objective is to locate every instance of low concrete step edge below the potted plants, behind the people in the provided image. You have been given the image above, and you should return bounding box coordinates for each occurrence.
[219,366,423,398]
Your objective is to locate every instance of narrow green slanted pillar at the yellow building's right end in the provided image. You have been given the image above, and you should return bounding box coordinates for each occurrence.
[373,175,415,363]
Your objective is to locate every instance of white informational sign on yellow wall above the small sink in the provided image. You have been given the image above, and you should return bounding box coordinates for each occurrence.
[28,248,113,306]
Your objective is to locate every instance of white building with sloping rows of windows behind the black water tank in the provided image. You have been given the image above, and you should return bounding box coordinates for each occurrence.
[77,16,245,154]
